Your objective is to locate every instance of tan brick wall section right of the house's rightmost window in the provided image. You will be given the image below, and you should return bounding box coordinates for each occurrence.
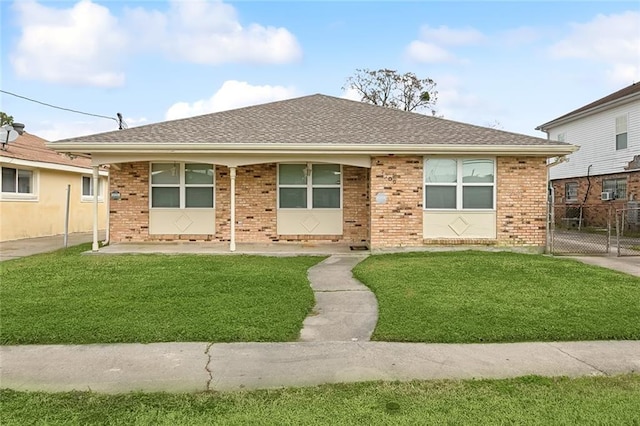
[496,157,547,248]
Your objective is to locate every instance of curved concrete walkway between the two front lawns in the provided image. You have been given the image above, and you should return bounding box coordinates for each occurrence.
[300,255,378,342]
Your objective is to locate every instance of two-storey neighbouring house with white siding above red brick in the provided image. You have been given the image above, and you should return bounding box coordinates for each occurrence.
[537,83,640,227]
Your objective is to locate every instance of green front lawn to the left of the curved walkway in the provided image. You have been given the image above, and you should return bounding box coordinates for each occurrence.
[0,245,321,345]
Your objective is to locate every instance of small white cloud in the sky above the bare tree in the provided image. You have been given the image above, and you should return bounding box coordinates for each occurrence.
[405,25,485,64]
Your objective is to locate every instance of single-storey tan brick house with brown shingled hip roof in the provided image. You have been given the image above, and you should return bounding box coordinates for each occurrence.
[50,95,575,251]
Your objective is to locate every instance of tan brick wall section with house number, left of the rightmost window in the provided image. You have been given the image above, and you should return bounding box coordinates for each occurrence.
[370,156,423,249]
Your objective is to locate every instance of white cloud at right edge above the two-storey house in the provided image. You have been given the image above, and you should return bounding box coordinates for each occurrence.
[549,11,640,84]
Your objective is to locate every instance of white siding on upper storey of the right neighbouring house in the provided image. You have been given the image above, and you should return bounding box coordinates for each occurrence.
[549,100,640,179]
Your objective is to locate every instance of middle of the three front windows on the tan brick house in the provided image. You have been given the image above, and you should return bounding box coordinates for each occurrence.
[278,163,342,209]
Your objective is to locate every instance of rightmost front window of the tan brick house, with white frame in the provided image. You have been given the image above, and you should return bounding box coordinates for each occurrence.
[424,158,495,210]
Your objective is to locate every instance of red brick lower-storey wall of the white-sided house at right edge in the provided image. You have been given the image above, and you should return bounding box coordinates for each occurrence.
[553,171,640,228]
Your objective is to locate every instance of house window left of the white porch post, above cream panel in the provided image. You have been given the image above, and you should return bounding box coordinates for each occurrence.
[150,163,214,208]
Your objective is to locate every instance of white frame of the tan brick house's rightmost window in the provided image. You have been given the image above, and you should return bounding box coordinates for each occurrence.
[422,157,498,212]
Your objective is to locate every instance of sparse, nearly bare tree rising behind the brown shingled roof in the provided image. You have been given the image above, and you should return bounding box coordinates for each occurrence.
[342,68,438,115]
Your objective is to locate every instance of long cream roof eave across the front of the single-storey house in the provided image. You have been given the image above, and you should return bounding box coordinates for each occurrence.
[47,142,578,156]
